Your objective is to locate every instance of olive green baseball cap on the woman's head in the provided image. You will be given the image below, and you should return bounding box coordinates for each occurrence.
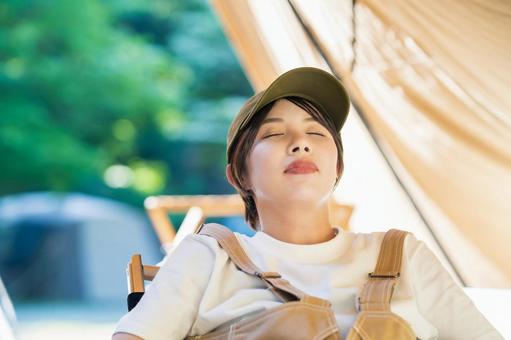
[227,67,350,163]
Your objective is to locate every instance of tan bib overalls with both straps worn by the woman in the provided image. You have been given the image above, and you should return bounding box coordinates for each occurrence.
[186,223,416,340]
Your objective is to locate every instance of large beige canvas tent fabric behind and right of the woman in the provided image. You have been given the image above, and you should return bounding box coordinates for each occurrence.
[212,0,511,288]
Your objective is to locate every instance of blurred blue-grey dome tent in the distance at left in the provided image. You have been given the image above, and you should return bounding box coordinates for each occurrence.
[0,192,161,302]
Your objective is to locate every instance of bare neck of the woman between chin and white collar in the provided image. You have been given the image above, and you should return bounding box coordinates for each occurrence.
[256,200,335,244]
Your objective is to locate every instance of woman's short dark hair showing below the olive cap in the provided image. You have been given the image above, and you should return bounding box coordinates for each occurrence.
[227,96,344,230]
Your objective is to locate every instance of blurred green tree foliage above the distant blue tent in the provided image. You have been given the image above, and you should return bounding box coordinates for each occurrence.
[0,0,252,206]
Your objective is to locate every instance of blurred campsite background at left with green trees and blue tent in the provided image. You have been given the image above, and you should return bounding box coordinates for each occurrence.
[0,0,253,339]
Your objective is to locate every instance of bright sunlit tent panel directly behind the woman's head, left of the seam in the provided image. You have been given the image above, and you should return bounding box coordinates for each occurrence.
[209,1,462,283]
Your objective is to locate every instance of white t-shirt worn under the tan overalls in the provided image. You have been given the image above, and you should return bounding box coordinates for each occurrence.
[115,224,503,340]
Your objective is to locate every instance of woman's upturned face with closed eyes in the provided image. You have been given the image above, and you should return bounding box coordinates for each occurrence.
[247,99,337,205]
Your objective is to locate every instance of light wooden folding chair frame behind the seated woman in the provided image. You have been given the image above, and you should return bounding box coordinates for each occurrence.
[126,194,354,310]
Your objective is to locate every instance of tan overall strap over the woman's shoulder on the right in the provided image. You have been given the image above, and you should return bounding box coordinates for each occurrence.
[358,229,408,311]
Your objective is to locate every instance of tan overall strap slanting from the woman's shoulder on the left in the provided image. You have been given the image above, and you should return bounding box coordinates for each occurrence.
[196,223,331,307]
